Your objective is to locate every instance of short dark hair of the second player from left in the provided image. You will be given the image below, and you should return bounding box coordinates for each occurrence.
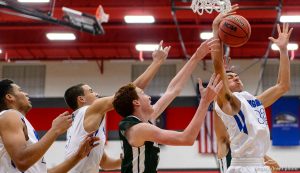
[64,83,85,110]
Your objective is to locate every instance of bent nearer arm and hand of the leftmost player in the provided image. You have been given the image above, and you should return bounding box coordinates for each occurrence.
[0,111,72,172]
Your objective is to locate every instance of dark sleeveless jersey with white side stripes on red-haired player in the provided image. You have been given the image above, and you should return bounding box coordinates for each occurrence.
[119,116,160,173]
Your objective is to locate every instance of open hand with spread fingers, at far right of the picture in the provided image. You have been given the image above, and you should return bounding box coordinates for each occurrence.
[269,23,293,50]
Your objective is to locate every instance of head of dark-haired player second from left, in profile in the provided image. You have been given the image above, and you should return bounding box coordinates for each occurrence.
[64,84,99,110]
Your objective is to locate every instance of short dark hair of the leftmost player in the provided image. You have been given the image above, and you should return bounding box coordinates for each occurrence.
[0,79,14,111]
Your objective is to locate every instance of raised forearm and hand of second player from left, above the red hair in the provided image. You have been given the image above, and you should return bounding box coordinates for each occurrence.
[133,41,171,89]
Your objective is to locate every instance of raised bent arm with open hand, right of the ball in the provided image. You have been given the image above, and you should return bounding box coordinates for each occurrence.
[257,23,293,107]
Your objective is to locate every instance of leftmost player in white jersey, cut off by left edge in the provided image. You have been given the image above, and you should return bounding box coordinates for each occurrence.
[0,79,99,173]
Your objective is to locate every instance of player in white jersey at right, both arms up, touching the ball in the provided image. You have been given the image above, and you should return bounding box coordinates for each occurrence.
[212,6,292,173]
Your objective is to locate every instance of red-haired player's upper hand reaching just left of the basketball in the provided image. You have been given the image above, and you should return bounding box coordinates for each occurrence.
[195,38,221,60]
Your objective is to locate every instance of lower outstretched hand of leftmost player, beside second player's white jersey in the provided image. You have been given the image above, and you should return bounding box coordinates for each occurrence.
[77,132,99,159]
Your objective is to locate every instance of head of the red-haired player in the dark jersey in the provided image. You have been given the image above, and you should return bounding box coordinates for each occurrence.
[113,83,153,117]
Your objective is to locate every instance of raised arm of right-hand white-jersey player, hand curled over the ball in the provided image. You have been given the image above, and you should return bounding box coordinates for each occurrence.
[211,5,240,115]
